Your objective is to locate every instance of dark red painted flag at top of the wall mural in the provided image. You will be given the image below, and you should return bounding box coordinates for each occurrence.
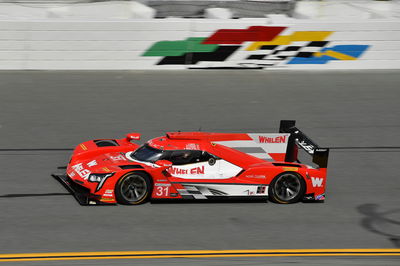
[203,26,286,44]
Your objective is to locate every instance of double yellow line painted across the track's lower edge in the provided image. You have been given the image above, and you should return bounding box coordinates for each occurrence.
[0,249,400,262]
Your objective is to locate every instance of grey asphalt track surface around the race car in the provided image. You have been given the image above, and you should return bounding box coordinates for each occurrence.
[0,71,400,265]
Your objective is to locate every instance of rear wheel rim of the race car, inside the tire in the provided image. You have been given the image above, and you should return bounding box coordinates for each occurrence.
[274,174,301,201]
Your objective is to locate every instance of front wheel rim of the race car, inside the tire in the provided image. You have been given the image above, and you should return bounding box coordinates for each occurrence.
[121,175,147,202]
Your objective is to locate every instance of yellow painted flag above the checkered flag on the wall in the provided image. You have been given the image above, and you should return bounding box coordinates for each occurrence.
[246,31,333,51]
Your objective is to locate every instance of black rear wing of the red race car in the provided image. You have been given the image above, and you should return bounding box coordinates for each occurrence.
[279,120,329,168]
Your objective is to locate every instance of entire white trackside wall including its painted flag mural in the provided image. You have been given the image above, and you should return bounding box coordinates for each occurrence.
[0,15,400,70]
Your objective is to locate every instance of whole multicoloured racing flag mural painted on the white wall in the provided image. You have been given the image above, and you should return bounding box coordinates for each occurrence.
[143,26,369,68]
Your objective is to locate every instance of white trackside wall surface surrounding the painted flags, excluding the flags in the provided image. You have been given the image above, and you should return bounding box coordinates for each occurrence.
[0,16,400,70]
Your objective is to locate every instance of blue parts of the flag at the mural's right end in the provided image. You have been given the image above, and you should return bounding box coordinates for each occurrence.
[287,45,369,64]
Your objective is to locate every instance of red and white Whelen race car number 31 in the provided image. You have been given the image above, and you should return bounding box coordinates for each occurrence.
[53,120,329,205]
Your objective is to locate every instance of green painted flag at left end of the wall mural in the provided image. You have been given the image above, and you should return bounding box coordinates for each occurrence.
[143,37,218,56]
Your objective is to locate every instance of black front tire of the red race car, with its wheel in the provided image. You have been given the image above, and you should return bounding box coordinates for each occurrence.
[115,172,153,205]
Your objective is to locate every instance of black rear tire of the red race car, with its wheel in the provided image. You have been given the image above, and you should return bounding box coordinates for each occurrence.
[268,172,306,204]
